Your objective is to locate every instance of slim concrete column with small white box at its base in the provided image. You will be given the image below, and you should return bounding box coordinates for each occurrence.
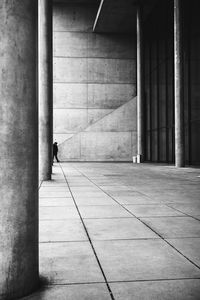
[137,6,145,163]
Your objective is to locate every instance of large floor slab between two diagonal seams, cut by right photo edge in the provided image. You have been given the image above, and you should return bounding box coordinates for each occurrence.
[94,239,200,281]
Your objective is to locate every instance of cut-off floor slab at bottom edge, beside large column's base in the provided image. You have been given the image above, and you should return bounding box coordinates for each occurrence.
[22,283,110,300]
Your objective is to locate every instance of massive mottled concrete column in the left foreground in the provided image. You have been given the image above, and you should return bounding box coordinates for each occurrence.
[0,0,39,299]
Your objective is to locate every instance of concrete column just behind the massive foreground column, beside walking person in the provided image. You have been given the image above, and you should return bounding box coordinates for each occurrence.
[38,0,53,180]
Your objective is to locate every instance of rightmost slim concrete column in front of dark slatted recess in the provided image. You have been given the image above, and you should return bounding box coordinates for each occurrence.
[174,0,185,167]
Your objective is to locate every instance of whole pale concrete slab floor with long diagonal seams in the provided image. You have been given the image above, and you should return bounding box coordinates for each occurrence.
[23,163,200,300]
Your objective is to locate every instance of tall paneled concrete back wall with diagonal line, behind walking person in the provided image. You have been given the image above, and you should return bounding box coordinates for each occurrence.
[53,3,136,161]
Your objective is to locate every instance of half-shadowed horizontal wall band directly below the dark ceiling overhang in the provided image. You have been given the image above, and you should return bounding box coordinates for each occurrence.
[54,31,136,59]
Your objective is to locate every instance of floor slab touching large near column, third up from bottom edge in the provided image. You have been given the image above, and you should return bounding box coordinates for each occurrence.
[40,219,88,242]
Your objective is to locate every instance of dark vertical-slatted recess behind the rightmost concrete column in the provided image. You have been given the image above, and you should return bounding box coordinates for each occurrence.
[145,0,200,165]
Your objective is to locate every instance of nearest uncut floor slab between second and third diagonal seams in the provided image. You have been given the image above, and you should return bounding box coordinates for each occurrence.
[125,204,184,217]
